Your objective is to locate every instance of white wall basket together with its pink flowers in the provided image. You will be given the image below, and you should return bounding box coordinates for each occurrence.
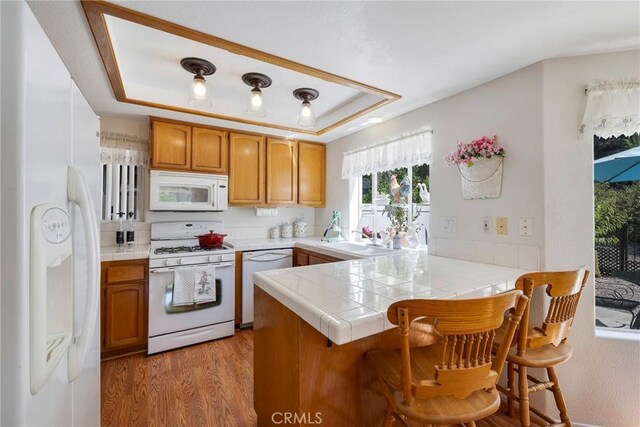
[445,136,505,200]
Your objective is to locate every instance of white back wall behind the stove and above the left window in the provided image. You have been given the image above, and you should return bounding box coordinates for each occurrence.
[100,116,315,246]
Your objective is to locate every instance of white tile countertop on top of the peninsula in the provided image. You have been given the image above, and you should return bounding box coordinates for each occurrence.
[253,251,527,344]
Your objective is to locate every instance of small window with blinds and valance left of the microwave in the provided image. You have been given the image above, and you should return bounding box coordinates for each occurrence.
[100,131,149,221]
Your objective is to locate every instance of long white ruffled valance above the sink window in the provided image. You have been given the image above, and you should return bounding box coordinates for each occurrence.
[342,130,433,179]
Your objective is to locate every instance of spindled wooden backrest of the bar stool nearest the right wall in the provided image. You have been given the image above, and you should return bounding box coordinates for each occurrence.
[516,267,589,356]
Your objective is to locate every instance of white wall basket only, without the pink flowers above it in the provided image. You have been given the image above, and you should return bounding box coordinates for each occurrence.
[458,156,504,200]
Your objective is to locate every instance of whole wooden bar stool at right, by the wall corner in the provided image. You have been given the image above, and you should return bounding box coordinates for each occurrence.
[494,268,589,426]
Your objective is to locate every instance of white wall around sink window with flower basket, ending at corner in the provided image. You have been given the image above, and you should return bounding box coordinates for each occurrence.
[324,64,544,269]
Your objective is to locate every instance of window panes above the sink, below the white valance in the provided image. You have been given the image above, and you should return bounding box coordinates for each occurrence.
[359,163,429,245]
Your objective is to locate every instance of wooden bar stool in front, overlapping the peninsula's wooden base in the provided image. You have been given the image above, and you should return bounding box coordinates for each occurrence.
[365,290,527,426]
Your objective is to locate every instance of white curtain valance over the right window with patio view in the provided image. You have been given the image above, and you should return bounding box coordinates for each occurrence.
[580,78,640,138]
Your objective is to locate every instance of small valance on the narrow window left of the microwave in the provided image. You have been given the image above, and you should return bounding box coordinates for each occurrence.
[100,131,149,166]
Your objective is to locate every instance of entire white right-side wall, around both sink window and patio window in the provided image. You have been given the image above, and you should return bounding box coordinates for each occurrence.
[324,51,640,426]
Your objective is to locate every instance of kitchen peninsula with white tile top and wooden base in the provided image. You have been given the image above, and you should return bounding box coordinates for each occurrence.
[253,251,526,426]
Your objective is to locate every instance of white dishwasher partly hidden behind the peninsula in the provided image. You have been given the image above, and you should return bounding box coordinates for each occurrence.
[241,249,293,327]
